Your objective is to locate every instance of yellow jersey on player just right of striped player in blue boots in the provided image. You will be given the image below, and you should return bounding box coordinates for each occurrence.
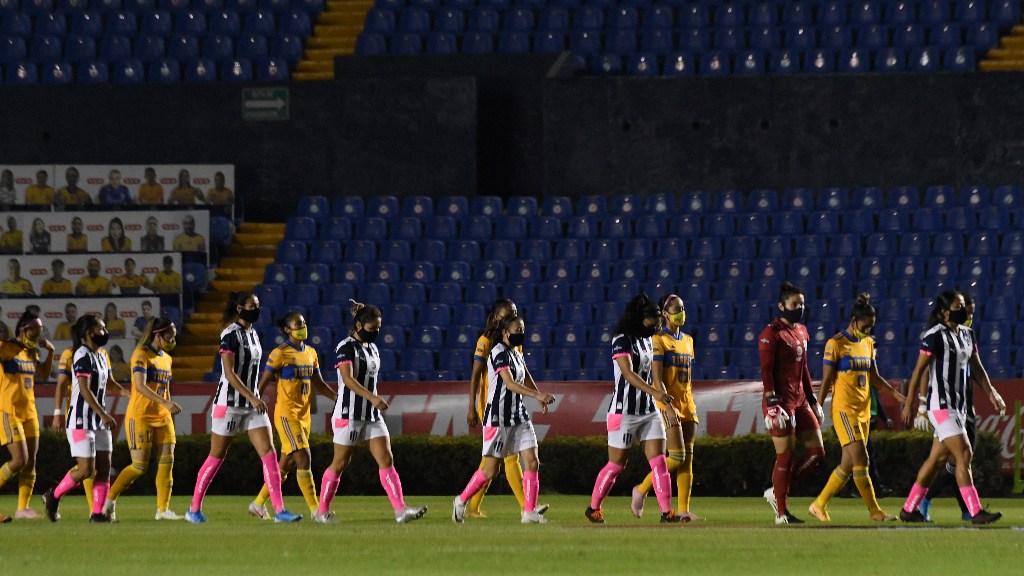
[263,341,319,421]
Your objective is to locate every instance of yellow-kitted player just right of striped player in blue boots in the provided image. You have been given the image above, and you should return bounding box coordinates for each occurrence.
[249,312,338,518]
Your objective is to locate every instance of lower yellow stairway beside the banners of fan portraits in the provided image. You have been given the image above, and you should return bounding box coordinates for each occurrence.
[174,222,285,382]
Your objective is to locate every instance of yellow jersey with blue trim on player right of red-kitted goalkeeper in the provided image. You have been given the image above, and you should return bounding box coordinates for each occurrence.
[823,330,874,420]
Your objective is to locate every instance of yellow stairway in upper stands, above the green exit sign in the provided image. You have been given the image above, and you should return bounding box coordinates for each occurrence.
[292,0,374,80]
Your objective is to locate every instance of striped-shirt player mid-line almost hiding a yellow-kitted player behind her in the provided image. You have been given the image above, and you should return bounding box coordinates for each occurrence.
[452,315,555,524]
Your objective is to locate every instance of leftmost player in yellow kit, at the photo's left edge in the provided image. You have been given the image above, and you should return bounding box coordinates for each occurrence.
[0,312,54,522]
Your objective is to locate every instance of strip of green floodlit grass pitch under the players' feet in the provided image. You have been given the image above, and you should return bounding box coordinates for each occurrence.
[0,494,1024,576]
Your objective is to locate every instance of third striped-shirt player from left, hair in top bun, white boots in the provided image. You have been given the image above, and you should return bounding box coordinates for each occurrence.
[313,300,427,524]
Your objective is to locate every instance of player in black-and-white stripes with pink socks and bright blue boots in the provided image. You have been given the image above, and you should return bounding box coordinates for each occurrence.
[185,292,302,524]
